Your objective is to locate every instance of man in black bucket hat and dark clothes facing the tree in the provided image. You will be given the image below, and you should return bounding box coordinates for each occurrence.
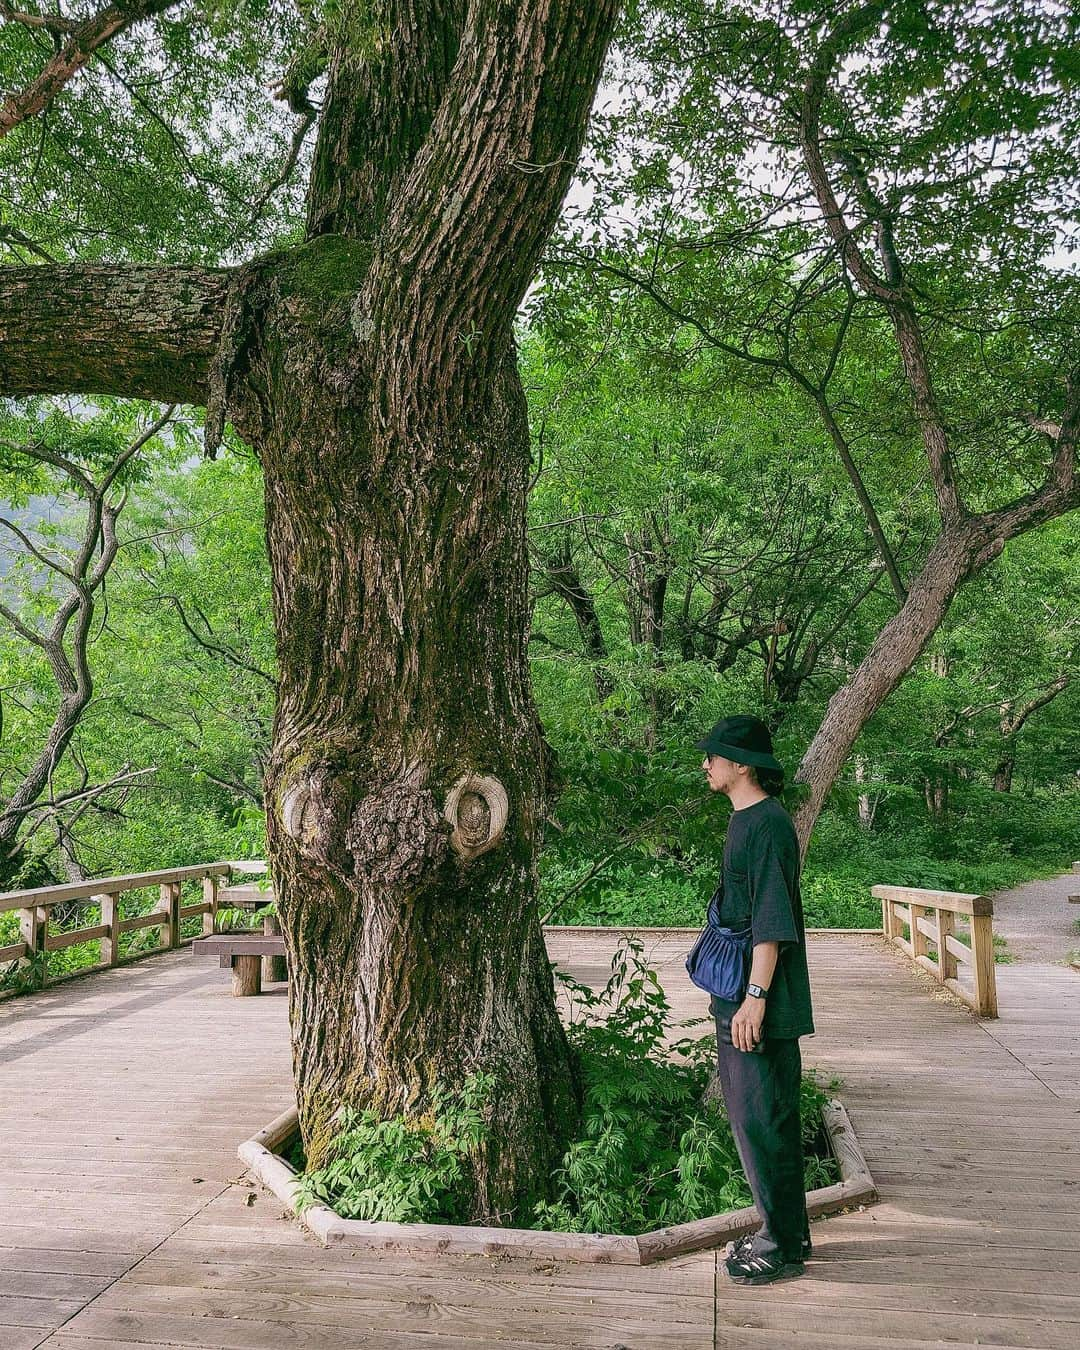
[697,716,814,1284]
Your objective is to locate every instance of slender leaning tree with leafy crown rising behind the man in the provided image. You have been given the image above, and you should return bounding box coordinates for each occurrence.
[548,0,1080,848]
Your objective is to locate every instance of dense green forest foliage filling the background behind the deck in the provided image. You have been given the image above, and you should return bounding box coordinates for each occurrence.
[0,3,1080,972]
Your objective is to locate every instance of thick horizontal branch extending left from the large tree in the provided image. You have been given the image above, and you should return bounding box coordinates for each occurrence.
[0,265,232,404]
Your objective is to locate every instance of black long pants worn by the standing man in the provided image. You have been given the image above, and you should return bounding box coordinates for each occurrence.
[717,1035,810,1261]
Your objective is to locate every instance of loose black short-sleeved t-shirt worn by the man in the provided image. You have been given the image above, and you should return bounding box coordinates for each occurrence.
[713,797,814,1040]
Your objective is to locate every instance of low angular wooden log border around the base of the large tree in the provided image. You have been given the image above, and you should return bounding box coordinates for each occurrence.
[236,1099,878,1265]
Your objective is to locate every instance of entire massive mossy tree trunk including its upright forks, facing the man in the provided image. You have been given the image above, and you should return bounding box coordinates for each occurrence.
[220,0,614,1222]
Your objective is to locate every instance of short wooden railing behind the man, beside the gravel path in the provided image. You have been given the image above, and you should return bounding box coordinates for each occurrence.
[871,886,998,1017]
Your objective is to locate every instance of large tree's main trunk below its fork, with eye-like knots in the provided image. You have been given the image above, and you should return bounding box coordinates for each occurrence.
[259,301,578,1218]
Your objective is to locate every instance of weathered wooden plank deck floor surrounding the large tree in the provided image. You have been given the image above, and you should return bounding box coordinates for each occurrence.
[0,878,1080,1350]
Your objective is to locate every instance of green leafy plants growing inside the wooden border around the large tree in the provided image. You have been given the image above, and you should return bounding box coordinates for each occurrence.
[294,940,838,1234]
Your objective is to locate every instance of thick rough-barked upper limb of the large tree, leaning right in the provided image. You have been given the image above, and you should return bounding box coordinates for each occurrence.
[365,0,618,375]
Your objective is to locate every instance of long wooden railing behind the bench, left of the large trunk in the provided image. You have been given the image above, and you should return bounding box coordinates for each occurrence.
[0,861,266,991]
